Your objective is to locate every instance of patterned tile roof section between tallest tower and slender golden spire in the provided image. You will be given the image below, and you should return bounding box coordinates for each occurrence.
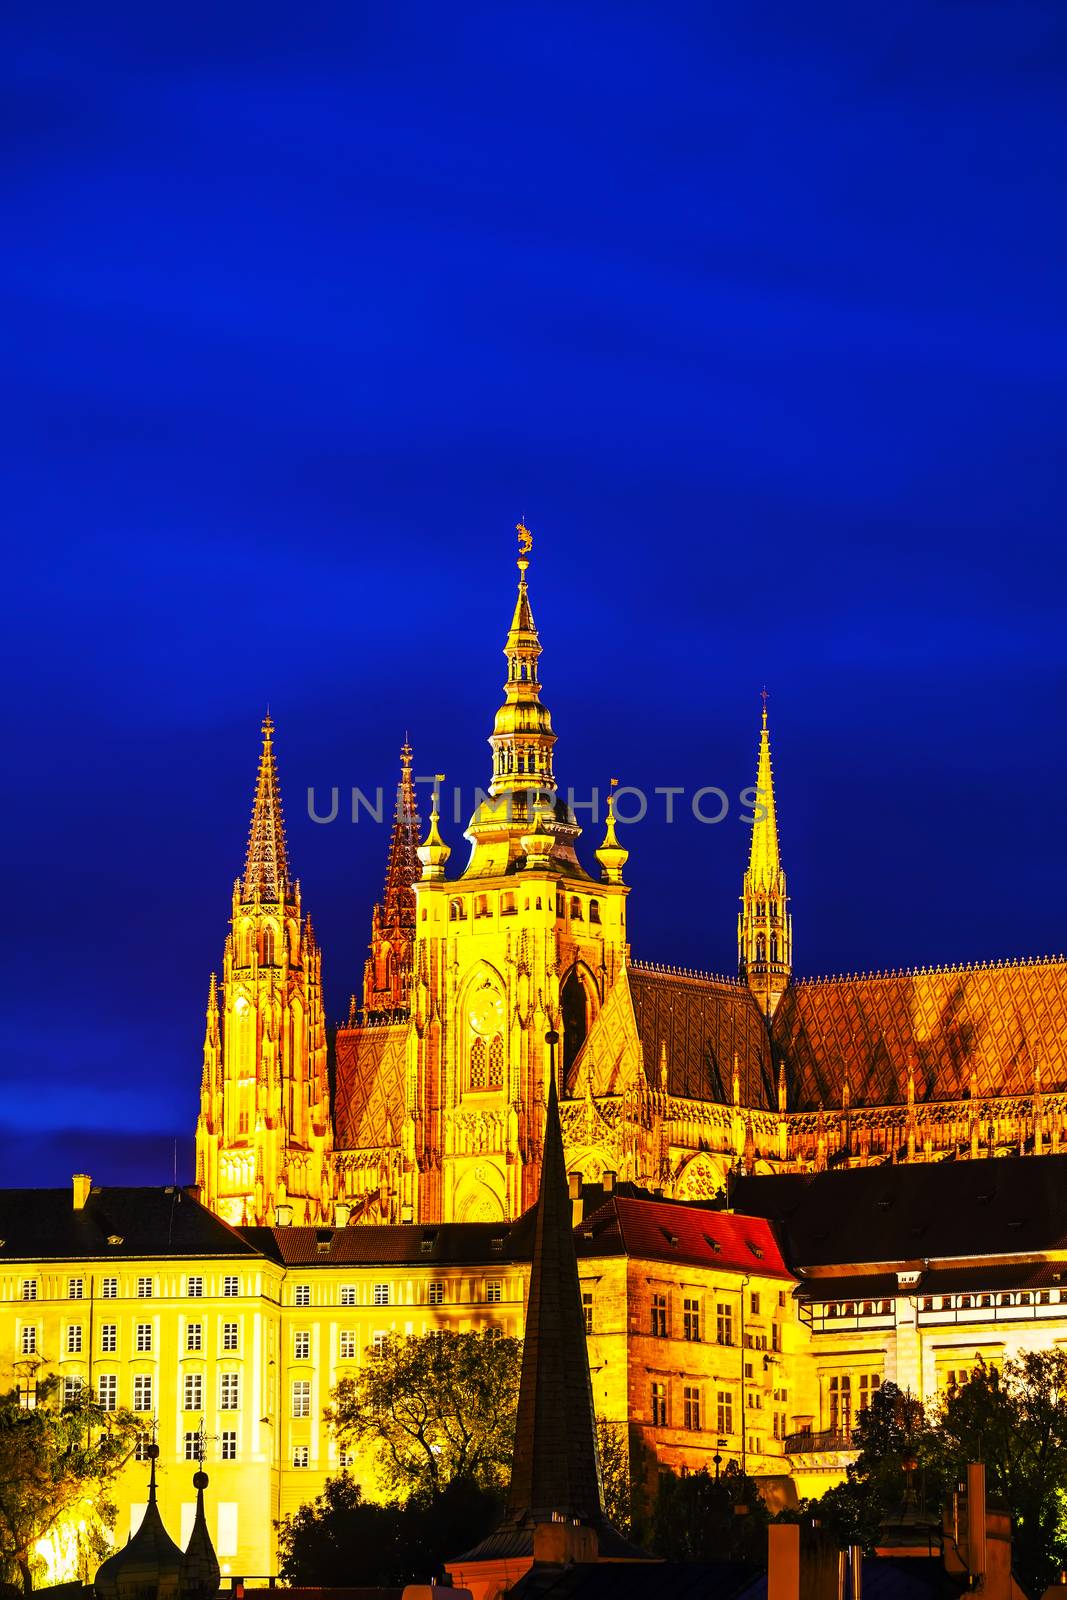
[627,963,774,1107]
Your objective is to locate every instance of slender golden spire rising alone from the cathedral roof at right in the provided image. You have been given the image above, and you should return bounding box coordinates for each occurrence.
[737,690,793,1018]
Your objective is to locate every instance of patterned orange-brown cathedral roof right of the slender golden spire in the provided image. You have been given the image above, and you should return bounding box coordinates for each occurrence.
[773,957,1067,1110]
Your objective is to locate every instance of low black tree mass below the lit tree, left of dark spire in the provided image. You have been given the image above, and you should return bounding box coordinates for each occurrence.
[277,1472,499,1587]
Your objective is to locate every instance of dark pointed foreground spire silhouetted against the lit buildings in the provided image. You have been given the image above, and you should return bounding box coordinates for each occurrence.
[506,1074,603,1528]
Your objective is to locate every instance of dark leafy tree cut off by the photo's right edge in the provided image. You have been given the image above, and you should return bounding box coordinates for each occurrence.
[931,1350,1067,1594]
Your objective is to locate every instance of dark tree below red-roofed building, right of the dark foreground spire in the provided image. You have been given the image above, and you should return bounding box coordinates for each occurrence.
[651,1461,769,1566]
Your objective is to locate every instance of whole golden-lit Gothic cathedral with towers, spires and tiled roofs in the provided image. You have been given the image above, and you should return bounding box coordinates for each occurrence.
[197,528,1067,1224]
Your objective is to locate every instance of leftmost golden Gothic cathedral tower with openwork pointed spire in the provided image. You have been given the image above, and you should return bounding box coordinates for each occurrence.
[197,717,333,1224]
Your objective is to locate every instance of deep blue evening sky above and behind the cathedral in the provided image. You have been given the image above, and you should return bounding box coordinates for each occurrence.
[0,0,1067,1182]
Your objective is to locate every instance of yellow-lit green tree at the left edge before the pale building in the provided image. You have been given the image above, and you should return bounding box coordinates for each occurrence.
[0,1378,142,1594]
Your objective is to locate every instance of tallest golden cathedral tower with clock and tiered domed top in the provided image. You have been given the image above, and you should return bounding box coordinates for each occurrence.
[402,525,629,1221]
